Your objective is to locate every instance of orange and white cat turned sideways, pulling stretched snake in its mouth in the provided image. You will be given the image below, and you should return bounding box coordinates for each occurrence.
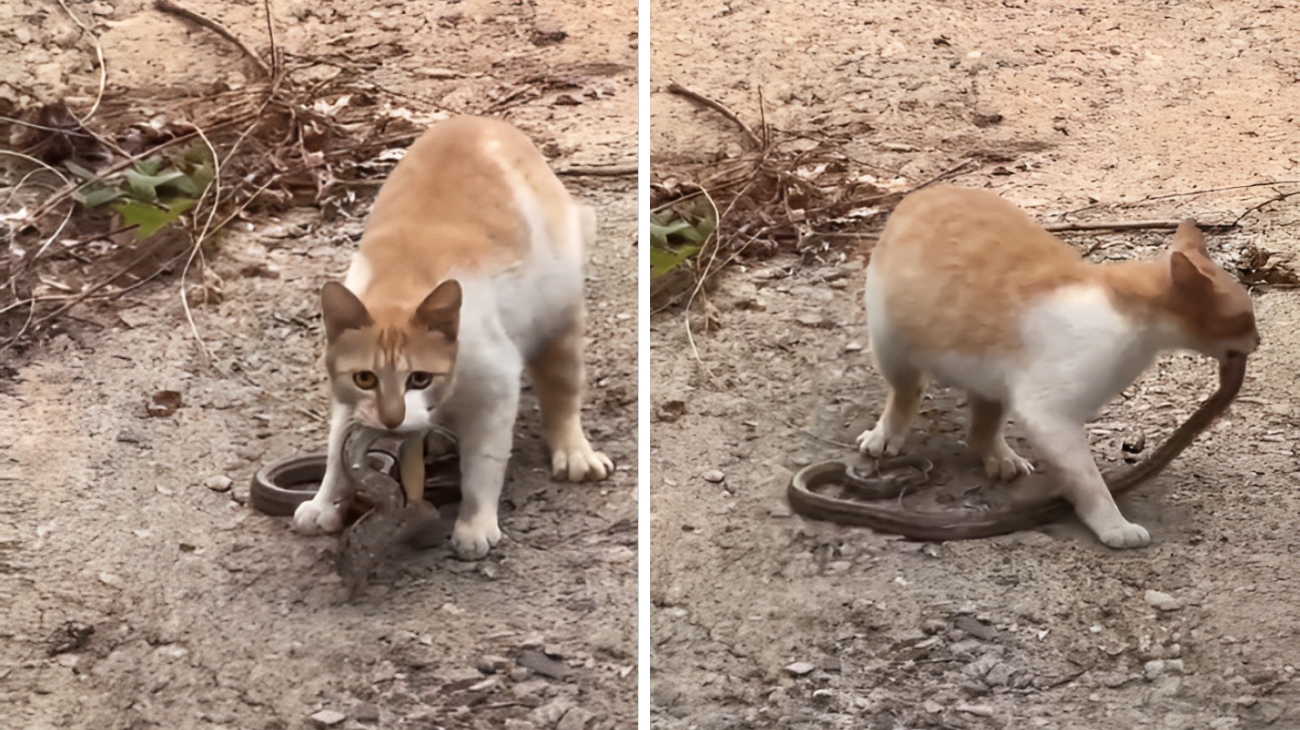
[858,186,1260,548]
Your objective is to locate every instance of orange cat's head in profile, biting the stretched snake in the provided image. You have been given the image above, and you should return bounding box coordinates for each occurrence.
[1169,221,1260,362]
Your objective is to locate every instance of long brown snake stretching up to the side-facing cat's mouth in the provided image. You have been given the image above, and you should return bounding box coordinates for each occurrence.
[787,353,1245,540]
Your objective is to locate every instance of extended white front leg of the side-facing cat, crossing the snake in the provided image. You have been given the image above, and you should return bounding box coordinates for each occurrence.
[1017,407,1151,548]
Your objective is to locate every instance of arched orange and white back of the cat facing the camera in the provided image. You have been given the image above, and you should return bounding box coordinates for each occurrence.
[360,117,582,290]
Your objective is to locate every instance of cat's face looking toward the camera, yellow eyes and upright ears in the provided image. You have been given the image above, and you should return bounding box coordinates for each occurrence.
[321,281,460,433]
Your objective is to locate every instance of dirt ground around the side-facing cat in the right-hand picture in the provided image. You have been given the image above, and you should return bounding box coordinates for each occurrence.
[650,0,1300,730]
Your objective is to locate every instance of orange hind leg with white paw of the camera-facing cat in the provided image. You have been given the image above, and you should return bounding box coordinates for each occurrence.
[528,317,614,482]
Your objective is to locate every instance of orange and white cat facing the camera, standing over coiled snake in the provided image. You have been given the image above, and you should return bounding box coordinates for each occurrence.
[294,117,614,559]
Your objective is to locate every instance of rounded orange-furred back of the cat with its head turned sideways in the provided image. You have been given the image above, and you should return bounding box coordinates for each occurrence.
[867,186,1091,352]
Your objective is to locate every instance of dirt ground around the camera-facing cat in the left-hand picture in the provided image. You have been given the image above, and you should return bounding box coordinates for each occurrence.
[0,0,637,730]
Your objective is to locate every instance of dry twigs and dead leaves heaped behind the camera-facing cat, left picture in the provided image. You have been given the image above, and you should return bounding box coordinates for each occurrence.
[0,30,421,352]
